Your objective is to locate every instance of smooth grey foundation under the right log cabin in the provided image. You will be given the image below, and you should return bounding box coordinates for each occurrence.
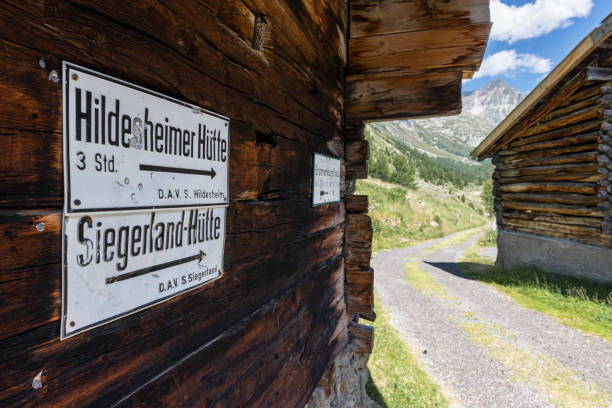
[496,229,612,283]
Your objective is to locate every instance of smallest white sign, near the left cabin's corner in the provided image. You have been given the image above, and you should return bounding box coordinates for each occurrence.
[312,153,340,206]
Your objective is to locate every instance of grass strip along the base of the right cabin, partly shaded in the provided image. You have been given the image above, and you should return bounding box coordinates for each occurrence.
[459,233,612,342]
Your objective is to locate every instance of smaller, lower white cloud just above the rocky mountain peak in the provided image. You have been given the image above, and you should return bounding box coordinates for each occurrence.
[474,50,552,79]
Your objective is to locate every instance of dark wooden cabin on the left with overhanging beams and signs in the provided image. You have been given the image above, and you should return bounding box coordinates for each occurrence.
[0,0,490,407]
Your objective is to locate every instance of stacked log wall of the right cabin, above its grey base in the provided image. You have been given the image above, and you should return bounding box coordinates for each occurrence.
[493,47,612,247]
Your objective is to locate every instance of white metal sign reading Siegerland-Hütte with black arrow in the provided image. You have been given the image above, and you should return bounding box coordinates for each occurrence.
[61,207,226,339]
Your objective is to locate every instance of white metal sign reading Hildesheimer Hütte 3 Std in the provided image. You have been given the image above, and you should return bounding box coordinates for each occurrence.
[63,62,230,213]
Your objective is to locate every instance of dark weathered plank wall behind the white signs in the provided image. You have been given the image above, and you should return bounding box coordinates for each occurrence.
[0,0,352,407]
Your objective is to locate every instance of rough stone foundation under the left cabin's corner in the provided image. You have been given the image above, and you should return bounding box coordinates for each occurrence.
[305,344,380,408]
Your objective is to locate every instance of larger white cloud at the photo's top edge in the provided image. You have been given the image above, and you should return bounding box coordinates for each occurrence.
[491,0,593,44]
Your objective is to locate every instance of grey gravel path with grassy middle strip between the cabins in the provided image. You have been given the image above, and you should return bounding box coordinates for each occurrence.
[372,228,612,408]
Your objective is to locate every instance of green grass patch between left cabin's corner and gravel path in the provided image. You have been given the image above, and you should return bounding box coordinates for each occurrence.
[366,296,448,408]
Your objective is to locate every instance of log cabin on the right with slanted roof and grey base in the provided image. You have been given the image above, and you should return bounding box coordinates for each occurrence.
[472,11,612,282]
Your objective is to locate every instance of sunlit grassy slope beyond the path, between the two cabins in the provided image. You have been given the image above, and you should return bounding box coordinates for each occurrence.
[356,179,488,252]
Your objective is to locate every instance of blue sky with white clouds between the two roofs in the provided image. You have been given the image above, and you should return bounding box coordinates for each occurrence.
[463,0,612,93]
